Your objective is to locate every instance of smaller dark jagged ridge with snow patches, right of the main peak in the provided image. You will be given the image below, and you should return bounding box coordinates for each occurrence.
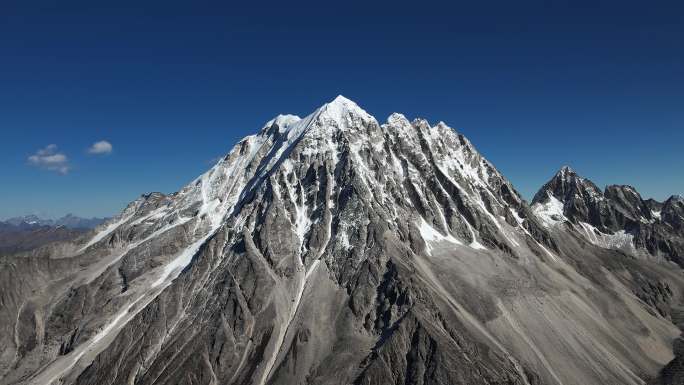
[532,167,684,266]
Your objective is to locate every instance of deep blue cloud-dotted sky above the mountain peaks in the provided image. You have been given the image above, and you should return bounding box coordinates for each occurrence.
[0,0,684,218]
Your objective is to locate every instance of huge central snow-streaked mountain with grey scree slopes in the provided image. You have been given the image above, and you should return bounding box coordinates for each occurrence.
[0,97,684,385]
